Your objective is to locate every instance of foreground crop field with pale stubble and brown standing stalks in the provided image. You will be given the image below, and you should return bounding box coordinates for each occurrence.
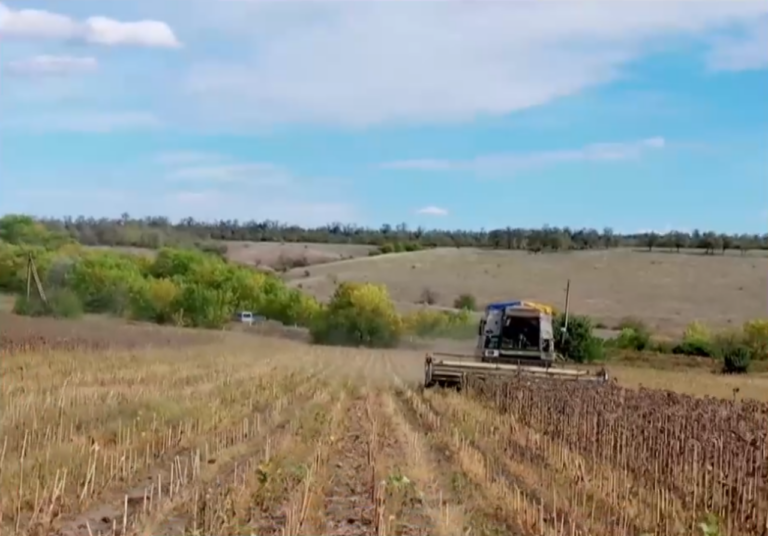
[0,317,768,536]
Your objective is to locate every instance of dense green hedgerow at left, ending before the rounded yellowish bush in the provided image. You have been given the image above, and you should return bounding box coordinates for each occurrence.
[0,244,320,328]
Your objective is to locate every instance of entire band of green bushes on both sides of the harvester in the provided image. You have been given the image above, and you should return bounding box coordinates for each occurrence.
[0,242,768,372]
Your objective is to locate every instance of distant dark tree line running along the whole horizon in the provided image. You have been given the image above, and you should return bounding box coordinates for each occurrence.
[0,214,768,254]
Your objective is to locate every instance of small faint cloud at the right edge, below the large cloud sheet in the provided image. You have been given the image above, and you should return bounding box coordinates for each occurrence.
[707,18,768,71]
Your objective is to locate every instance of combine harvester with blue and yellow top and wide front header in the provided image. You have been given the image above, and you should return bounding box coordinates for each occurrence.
[424,285,608,388]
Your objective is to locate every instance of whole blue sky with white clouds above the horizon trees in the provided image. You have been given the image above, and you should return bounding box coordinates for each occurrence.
[0,0,768,233]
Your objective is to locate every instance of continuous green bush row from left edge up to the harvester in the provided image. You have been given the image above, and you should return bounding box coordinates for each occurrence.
[0,243,474,347]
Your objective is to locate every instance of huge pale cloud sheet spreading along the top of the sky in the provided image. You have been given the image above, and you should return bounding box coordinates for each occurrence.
[179,0,768,127]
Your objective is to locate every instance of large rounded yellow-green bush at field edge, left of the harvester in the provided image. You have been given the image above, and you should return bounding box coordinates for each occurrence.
[310,282,402,348]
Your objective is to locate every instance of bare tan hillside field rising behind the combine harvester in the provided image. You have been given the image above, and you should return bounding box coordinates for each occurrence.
[289,248,768,336]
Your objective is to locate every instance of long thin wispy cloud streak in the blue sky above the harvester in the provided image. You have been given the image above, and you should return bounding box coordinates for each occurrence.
[381,137,666,173]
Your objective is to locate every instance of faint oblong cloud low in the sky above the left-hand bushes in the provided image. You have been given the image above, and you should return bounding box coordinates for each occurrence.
[167,162,291,186]
